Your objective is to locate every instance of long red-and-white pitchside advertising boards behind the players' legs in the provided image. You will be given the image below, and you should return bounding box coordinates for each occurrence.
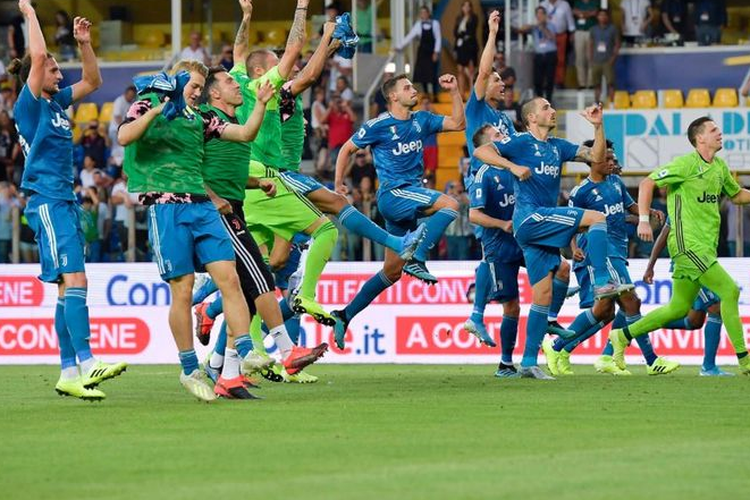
[0,259,750,364]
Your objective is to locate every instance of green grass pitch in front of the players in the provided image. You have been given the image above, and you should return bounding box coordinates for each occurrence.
[0,365,750,500]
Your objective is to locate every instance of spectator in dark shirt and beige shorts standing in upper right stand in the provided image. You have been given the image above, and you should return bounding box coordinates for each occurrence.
[589,9,620,103]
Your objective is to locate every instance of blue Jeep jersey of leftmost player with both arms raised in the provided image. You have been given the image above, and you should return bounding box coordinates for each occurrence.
[13,85,75,200]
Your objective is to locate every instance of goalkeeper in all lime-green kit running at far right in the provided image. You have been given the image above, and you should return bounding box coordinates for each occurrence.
[609,116,750,375]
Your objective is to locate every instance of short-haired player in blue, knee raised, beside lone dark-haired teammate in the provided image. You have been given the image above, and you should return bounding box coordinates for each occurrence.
[474,97,632,380]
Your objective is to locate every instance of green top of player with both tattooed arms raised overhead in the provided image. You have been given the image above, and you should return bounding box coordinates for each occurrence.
[229,63,286,169]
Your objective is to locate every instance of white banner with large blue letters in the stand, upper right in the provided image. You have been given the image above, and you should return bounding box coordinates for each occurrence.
[565,108,750,174]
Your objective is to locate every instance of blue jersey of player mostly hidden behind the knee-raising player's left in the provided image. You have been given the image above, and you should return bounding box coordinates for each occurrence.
[470,165,523,262]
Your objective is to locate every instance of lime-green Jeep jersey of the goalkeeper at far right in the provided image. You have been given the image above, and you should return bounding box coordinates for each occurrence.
[649,151,741,272]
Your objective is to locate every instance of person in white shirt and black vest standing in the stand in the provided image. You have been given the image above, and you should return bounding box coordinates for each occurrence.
[396,5,442,98]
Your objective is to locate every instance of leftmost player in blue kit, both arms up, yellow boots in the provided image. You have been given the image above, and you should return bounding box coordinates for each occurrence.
[8,0,127,401]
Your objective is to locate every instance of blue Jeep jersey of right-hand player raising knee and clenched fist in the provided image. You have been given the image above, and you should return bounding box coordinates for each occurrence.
[495,132,578,229]
